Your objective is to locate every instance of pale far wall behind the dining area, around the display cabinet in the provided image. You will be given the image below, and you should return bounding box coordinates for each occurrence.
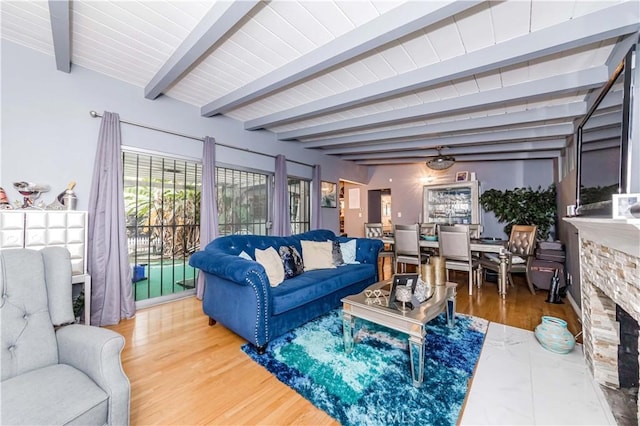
[365,160,554,238]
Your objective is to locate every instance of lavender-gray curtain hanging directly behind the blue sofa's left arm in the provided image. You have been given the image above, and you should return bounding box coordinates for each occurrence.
[196,136,218,299]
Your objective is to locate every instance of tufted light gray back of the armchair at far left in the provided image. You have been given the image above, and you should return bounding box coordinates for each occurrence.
[0,247,74,381]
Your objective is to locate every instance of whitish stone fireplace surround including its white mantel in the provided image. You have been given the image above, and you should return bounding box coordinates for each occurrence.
[565,218,640,419]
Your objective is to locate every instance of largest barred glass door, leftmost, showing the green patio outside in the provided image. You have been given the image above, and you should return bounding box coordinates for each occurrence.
[122,151,202,301]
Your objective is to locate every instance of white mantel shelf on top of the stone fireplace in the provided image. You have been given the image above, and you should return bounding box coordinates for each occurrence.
[564,217,640,258]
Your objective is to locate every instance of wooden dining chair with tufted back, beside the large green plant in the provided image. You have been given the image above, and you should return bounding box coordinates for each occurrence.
[480,225,538,294]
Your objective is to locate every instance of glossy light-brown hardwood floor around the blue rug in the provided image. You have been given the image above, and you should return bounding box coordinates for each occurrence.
[107,273,580,425]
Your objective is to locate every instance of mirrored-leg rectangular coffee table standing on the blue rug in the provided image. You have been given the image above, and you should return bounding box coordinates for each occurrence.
[342,280,457,387]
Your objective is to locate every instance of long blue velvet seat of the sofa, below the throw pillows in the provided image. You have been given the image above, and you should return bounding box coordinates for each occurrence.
[271,264,376,315]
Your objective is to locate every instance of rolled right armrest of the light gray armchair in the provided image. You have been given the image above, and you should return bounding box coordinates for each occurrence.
[56,324,131,425]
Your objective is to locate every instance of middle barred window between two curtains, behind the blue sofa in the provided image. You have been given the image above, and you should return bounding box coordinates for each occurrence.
[216,167,269,236]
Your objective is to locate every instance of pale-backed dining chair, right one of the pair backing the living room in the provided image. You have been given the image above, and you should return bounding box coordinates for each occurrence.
[438,225,482,295]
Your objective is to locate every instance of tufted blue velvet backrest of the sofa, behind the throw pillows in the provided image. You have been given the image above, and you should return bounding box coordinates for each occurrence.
[205,229,336,259]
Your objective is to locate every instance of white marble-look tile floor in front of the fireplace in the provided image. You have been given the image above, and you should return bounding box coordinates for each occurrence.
[460,323,616,425]
